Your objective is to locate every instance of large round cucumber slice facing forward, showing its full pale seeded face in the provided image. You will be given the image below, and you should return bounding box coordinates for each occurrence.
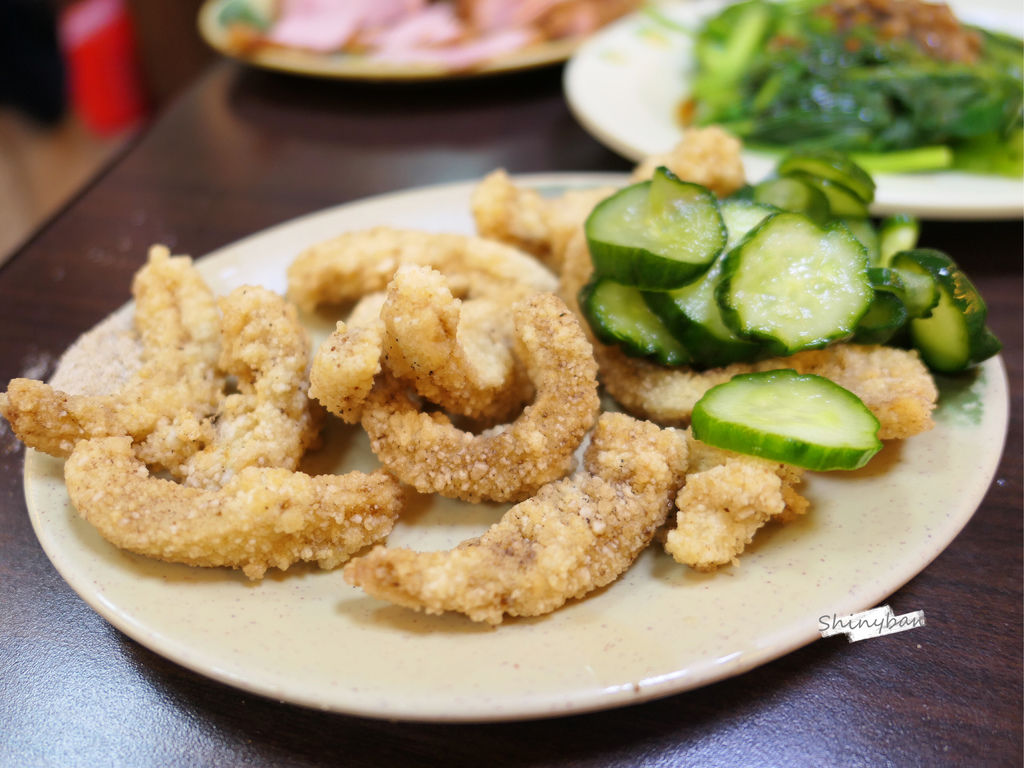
[716,213,874,354]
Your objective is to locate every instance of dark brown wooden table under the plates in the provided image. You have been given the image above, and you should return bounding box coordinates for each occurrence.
[0,62,1024,767]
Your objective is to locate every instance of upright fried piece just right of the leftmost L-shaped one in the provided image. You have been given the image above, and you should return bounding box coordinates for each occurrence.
[172,286,322,488]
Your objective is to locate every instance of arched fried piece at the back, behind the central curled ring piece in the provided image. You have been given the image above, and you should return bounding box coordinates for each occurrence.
[288,226,556,311]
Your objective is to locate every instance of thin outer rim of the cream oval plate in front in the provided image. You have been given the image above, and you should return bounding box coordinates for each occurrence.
[23,173,1010,723]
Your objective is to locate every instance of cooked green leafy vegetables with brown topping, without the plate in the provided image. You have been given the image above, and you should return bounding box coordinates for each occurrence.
[690,0,1024,176]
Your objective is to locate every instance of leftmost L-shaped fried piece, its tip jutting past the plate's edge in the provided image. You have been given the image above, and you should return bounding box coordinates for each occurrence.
[0,246,224,466]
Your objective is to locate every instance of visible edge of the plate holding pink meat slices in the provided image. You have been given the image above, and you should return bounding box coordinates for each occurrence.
[198,0,583,81]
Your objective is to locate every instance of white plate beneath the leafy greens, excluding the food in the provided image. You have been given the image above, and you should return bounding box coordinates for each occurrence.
[565,0,1024,219]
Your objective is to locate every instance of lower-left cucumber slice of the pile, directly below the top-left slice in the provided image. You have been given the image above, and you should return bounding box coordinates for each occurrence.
[580,278,690,366]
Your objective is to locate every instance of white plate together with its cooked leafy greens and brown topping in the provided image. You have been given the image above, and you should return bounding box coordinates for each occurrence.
[565,0,1024,219]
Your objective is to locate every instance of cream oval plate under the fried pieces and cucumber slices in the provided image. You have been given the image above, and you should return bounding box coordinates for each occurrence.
[25,174,1008,721]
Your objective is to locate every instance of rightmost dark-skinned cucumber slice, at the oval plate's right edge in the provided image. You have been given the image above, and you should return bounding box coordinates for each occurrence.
[897,248,1002,373]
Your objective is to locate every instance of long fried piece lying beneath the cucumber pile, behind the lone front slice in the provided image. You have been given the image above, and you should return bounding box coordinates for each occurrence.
[559,233,938,440]
